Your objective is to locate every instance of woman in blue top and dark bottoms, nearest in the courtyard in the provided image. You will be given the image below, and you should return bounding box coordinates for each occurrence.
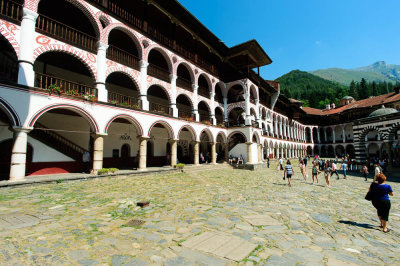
[369,173,393,233]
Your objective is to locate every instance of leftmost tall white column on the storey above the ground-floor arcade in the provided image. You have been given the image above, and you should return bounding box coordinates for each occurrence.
[18,8,39,86]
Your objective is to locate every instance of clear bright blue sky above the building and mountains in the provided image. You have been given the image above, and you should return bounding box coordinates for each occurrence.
[179,0,400,79]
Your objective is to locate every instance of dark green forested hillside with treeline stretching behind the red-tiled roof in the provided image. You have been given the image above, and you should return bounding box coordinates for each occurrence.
[276,70,400,109]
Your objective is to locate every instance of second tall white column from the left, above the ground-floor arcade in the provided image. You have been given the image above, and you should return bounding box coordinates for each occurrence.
[96,42,108,102]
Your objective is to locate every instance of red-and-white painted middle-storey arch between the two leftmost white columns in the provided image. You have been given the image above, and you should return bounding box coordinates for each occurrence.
[33,44,97,80]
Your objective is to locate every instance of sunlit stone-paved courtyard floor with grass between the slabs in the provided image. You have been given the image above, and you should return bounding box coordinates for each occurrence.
[0,163,400,265]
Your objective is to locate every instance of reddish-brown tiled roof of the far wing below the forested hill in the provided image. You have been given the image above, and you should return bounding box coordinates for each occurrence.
[303,92,400,115]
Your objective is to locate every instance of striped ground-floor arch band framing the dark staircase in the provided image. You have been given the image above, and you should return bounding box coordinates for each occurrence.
[28,104,100,133]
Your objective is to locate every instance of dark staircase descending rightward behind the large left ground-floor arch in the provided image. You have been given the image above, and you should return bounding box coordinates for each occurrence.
[29,123,86,162]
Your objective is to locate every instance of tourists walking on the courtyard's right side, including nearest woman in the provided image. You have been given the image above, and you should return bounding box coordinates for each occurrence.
[277,157,393,233]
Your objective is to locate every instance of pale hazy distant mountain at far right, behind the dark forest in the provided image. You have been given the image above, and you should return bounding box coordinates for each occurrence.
[309,61,400,85]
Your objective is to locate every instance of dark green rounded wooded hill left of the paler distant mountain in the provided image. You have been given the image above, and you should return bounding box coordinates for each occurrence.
[276,70,349,108]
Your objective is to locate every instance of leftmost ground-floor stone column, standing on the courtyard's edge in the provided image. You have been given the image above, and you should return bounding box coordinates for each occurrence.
[10,127,33,180]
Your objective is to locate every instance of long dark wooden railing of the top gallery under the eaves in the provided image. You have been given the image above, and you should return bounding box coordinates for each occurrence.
[86,0,219,76]
